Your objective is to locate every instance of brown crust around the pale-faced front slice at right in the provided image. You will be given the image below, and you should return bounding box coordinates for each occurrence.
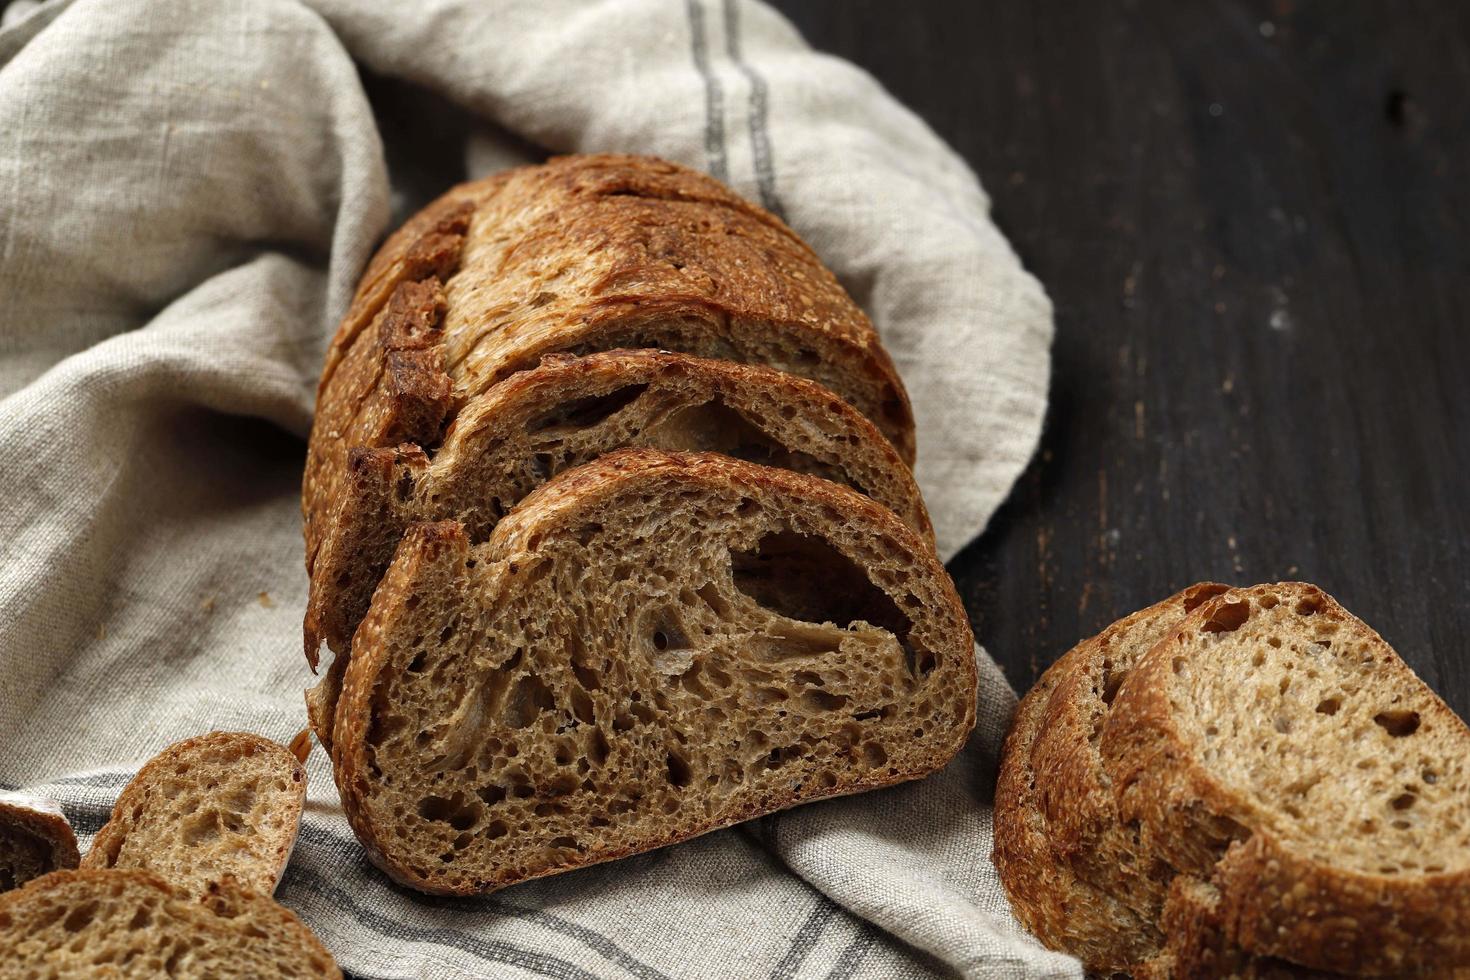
[1101,583,1470,974]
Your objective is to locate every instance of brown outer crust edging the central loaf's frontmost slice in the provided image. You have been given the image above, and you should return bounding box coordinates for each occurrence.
[332,450,976,893]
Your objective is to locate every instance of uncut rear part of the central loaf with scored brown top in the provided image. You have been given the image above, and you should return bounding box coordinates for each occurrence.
[303,156,914,570]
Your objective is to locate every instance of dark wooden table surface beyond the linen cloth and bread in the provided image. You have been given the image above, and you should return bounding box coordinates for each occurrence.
[779,0,1470,717]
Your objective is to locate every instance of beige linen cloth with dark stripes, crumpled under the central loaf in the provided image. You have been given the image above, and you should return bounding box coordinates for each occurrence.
[0,0,1080,979]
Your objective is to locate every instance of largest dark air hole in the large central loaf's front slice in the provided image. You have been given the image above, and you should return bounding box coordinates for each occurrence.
[731,530,935,676]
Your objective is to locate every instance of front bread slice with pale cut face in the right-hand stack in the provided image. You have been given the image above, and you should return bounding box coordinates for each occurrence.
[1101,583,1470,974]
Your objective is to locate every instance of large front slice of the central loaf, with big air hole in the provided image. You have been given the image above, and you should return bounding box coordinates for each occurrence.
[332,450,976,893]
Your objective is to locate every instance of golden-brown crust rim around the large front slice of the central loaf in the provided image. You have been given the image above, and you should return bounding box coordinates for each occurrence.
[332,450,976,893]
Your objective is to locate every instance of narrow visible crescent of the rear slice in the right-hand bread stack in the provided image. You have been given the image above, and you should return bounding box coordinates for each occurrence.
[1030,582,1227,923]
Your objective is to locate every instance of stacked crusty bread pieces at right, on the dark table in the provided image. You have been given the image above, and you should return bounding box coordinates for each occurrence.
[995,583,1470,980]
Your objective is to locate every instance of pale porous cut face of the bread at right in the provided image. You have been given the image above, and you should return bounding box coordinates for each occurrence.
[1169,586,1470,876]
